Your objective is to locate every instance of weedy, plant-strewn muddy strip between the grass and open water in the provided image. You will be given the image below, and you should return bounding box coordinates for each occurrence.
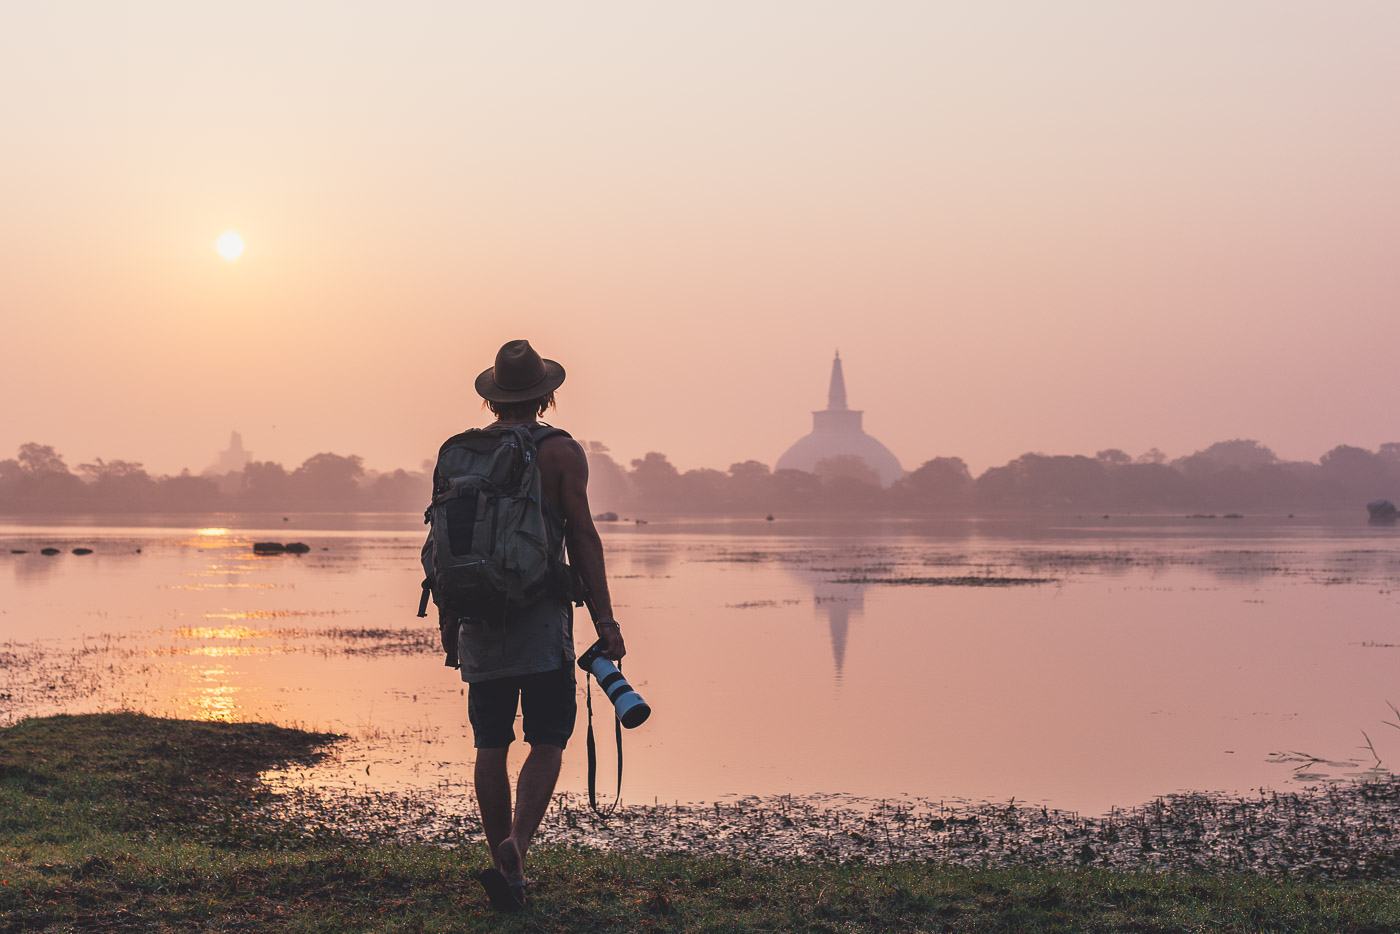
[269,761,1400,881]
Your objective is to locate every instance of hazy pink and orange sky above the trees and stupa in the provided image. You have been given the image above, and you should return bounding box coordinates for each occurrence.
[0,0,1400,472]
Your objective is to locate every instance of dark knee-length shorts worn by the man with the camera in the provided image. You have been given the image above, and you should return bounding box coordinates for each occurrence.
[466,662,578,749]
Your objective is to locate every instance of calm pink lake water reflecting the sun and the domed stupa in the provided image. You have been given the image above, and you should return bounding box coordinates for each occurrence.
[0,517,1400,812]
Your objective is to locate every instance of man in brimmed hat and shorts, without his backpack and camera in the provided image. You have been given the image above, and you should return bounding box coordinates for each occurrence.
[444,340,627,910]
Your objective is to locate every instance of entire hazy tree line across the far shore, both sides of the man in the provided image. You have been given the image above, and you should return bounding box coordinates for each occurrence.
[0,440,1400,515]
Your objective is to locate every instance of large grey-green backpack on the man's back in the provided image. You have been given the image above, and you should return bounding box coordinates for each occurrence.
[419,424,570,623]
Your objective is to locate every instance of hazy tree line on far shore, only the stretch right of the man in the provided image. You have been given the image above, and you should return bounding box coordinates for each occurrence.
[588,440,1400,515]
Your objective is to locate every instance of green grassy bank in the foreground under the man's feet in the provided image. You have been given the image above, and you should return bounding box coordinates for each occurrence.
[0,714,1400,934]
